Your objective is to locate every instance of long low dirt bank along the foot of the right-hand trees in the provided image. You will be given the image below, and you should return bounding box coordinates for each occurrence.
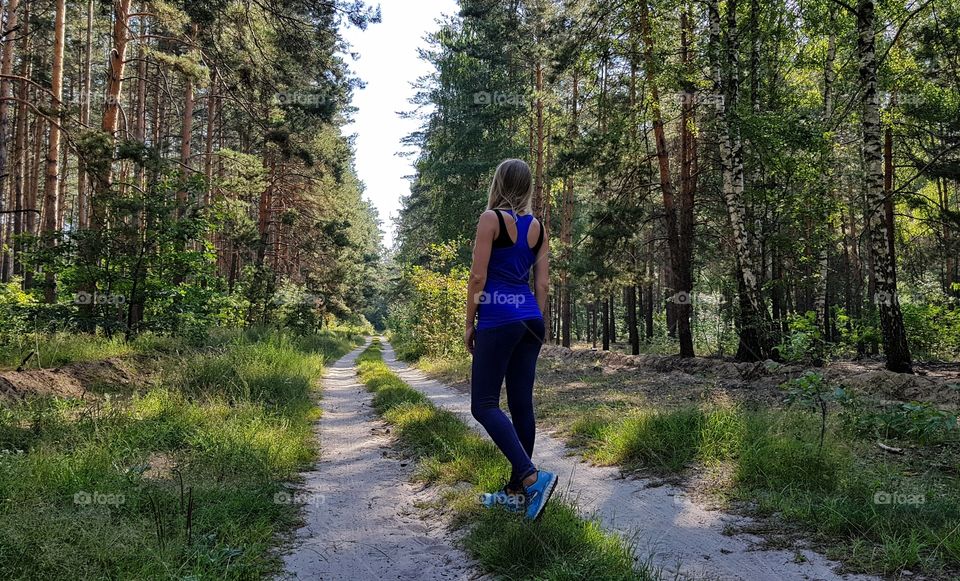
[543,345,960,406]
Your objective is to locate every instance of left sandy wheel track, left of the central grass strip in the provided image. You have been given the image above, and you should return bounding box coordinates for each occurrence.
[281,340,479,580]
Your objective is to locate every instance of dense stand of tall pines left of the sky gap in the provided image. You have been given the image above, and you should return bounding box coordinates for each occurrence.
[0,0,381,338]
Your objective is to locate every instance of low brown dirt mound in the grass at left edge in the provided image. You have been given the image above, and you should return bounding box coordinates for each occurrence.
[0,359,134,401]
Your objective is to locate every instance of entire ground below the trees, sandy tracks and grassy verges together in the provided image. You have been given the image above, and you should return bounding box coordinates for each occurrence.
[0,337,960,580]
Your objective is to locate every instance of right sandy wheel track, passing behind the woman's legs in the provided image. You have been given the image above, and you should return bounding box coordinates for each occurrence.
[383,342,872,581]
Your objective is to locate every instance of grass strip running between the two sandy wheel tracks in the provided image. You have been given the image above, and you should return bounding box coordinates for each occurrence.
[358,343,653,579]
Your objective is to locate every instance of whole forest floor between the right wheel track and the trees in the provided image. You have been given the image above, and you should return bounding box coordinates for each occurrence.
[418,346,960,579]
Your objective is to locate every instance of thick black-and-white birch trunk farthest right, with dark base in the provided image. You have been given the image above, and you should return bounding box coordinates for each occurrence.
[857,0,913,373]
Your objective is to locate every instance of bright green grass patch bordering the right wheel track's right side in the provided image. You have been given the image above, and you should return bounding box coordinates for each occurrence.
[570,406,960,574]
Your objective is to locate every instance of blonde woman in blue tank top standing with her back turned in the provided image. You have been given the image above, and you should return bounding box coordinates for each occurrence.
[463,159,557,520]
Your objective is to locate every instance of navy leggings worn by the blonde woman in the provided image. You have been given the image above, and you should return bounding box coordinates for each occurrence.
[470,319,545,489]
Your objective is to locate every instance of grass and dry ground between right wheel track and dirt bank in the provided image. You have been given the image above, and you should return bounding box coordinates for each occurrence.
[418,348,960,578]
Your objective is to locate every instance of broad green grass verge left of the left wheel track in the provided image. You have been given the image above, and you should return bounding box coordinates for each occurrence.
[0,333,356,579]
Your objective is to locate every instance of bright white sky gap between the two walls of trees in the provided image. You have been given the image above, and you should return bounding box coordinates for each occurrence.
[343,0,459,248]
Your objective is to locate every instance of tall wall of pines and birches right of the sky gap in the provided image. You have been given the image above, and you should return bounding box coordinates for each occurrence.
[394,0,960,371]
